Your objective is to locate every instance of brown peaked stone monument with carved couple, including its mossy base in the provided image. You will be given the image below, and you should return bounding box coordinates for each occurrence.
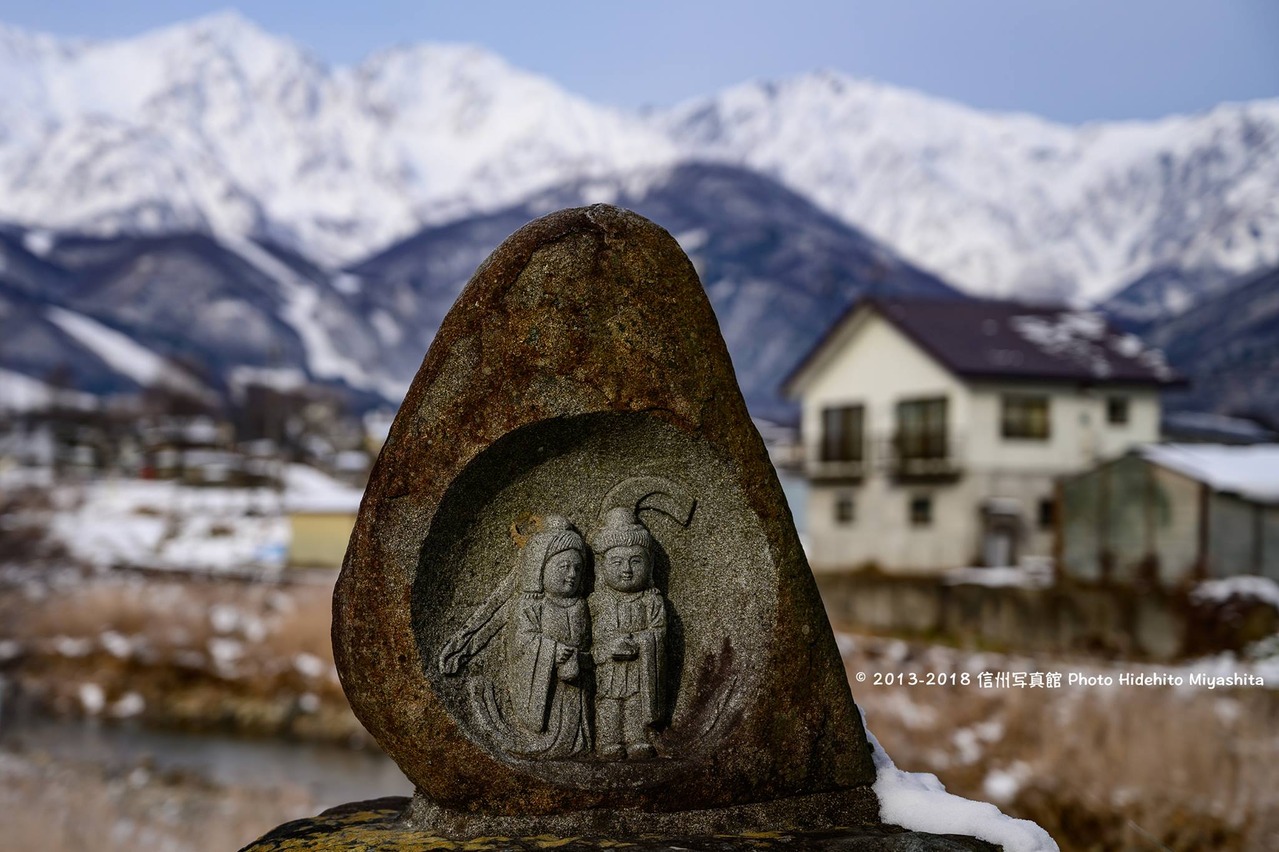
[237,205,1018,851]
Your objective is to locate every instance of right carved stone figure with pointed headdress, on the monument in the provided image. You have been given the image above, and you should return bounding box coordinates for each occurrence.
[590,508,666,760]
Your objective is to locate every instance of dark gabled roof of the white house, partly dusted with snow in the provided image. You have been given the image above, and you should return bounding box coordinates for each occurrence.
[784,298,1184,393]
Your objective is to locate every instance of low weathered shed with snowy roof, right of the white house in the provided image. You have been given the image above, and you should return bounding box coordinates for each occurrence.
[1058,444,1279,587]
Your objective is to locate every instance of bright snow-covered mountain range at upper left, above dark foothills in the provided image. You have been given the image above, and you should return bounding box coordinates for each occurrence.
[0,13,673,260]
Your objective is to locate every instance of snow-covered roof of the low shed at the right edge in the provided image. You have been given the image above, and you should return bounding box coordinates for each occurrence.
[1138,444,1279,503]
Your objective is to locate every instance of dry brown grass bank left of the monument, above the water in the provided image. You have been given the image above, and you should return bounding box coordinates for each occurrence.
[0,577,367,742]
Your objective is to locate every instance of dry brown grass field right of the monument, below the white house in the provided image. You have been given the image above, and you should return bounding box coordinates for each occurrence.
[848,638,1279,852]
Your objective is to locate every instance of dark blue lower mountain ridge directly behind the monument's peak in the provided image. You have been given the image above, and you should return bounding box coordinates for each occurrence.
[0,164,961,420]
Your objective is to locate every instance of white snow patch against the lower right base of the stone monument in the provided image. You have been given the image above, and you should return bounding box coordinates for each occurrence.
[862,701,1059,852]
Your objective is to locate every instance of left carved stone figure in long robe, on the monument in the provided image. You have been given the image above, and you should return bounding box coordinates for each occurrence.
[506,516,591,757]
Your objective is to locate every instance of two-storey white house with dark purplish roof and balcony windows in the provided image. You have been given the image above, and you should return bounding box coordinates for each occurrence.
[785,299,1181,573]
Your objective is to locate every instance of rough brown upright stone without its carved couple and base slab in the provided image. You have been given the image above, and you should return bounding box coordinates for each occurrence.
[333,206,877,824]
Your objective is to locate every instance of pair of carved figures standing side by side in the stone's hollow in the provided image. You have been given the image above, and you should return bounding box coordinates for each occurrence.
[440,481,691,760]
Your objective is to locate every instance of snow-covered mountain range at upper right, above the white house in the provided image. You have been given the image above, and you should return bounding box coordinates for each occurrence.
[660,72,1279,302]
